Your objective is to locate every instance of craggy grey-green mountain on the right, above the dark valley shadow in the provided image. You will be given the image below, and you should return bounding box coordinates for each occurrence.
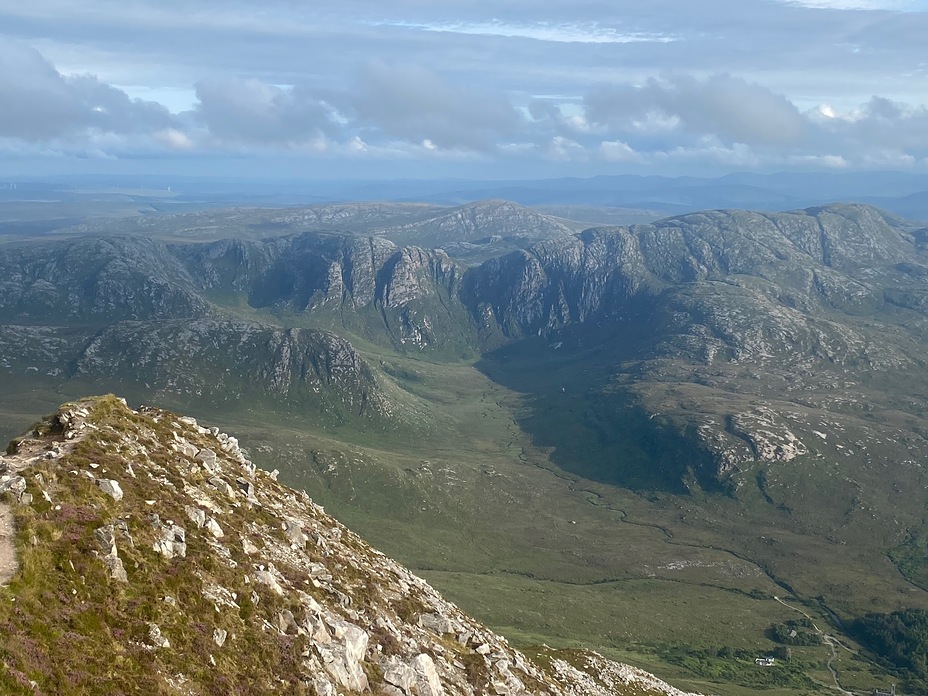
[465,206,928,482]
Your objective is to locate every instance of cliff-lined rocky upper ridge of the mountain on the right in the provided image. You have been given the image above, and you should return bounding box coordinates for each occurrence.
[465,206,919,352]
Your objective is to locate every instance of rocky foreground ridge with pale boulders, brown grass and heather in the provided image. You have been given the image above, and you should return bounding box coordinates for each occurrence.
[0,396,704,696]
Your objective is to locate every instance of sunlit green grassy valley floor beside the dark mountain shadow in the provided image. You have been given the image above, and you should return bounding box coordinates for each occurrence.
[147,356,919,694]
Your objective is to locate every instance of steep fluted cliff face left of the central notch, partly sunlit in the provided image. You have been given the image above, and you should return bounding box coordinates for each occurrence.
[172,234,476,355]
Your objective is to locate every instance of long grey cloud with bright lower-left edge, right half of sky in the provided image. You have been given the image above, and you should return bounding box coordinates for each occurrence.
[584,74,806,146]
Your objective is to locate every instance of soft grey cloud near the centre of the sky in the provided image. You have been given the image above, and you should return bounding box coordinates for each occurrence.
[345,61,525,151]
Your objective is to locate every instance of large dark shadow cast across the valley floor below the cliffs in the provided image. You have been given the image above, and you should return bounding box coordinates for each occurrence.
[477,332,723,494]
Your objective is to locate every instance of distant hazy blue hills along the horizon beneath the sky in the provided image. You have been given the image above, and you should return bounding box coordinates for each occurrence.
[0,171,928,235]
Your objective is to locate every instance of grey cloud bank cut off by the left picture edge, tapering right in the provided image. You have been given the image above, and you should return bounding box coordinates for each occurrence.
[0,40,172,142]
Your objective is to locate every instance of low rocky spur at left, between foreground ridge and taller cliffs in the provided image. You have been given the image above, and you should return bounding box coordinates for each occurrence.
[74,320,388,420]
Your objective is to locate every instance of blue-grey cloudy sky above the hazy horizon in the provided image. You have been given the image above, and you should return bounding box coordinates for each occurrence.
[0,0,928,179]
